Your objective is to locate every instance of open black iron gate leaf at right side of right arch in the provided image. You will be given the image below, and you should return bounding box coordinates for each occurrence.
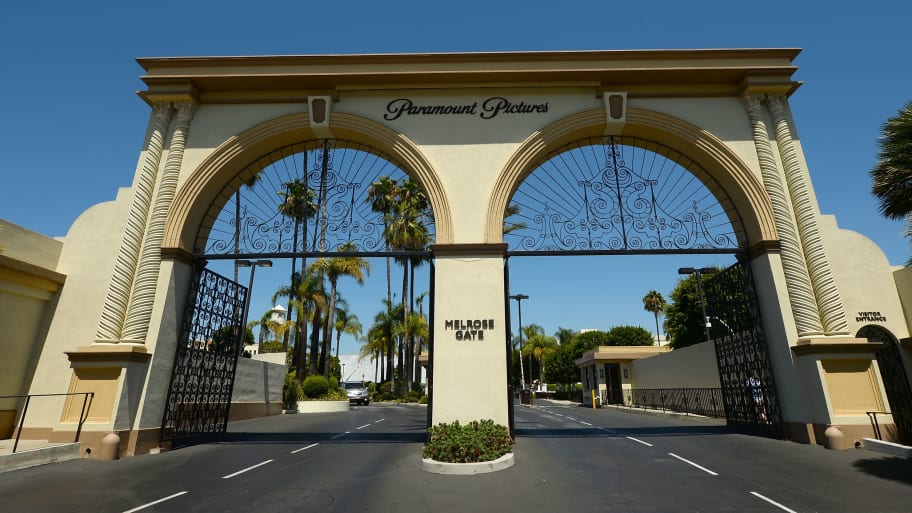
[703,262,783,438]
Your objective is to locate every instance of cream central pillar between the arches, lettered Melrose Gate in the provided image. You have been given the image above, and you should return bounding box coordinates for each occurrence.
[431,244,510,426]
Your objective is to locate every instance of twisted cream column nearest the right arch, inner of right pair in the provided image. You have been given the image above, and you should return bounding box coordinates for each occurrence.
[742,94,823,337]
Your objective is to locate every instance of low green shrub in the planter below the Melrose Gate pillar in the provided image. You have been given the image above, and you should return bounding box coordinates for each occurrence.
[422,420,513,463]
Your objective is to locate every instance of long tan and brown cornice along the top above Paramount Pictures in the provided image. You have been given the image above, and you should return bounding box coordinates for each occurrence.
[137,48,800,103]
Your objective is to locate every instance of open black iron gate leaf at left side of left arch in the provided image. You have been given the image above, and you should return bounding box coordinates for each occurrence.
[161,268,248,441]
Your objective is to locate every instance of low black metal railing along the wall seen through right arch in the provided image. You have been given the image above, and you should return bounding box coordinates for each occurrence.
[625,388,725,418]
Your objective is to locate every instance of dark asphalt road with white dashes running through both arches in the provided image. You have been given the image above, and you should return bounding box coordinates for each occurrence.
[0,401,912,513]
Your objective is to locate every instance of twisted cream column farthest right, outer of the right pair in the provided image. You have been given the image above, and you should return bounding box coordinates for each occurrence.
[767,95,849,335]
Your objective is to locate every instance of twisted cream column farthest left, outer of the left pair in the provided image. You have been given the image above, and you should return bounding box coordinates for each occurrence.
[95,103,171,343]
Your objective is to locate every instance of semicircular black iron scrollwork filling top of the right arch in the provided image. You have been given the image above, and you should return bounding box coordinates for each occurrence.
[504,137,739,253]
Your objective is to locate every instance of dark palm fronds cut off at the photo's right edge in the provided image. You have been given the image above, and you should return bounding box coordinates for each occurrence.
[870,102,912,265]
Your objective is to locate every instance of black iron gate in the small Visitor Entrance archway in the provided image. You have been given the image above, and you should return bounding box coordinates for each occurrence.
[858,326,912,445]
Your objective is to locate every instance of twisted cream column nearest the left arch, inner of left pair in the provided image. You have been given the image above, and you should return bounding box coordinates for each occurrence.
[122,102,194,343]
